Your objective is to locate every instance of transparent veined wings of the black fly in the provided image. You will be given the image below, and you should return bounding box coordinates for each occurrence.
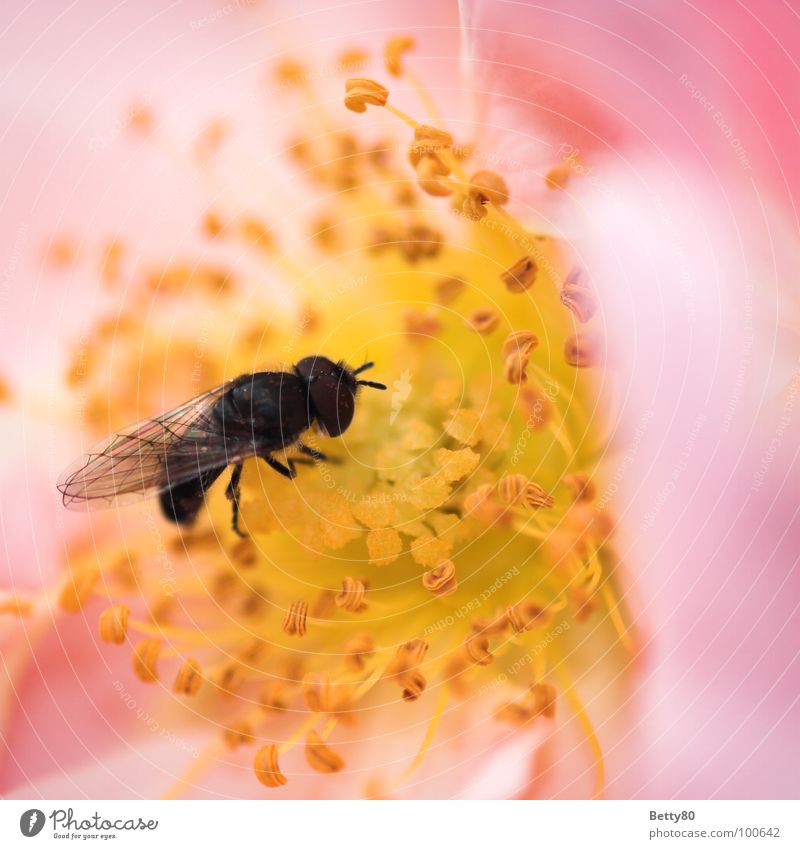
[58,381,252,510]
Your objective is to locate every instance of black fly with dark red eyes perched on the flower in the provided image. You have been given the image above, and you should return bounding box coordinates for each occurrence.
[58,356,386,536]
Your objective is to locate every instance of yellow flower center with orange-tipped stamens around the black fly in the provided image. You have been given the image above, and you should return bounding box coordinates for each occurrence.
[53,39,630,794]
